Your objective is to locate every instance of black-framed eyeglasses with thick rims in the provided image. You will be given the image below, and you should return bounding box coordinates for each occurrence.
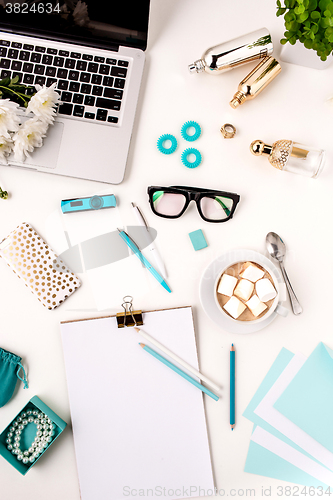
[148,186,240,222]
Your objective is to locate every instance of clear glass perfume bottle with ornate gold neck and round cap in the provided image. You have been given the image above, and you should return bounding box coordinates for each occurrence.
[250,140,325,179]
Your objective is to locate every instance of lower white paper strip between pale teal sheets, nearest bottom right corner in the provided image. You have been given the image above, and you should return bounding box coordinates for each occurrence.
[251,426,333,486]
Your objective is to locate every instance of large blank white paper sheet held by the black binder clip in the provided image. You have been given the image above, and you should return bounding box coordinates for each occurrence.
[61,307,214,500]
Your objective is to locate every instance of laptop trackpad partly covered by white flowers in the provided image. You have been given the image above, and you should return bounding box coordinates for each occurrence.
[8,122,64,168]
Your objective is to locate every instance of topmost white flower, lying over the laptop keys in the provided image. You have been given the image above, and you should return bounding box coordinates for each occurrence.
[26,83,60,125]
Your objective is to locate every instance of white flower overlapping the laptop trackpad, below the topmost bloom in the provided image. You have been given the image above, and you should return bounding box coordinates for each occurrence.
[13,117,48,162]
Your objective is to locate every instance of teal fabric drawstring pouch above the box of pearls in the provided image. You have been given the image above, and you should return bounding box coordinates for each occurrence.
[0,347,28,408]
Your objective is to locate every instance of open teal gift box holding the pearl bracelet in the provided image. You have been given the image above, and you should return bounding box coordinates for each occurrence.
[0,396,67,476]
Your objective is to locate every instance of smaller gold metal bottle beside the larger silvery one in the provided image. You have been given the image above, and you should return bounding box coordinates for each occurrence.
[230,57,281,108]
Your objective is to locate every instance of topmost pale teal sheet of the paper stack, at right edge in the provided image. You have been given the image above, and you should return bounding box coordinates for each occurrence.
[274,342,333,453]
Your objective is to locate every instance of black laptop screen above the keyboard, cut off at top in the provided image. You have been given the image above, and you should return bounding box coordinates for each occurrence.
[0,0,149,50]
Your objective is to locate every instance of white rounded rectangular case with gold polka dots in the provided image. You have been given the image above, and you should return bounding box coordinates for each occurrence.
[0,223,81,309]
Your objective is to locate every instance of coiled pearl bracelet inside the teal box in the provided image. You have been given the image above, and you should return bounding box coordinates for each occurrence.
[6,410,55,464]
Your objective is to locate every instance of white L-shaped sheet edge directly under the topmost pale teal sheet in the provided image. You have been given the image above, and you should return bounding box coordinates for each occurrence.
[254,353,333,470]
